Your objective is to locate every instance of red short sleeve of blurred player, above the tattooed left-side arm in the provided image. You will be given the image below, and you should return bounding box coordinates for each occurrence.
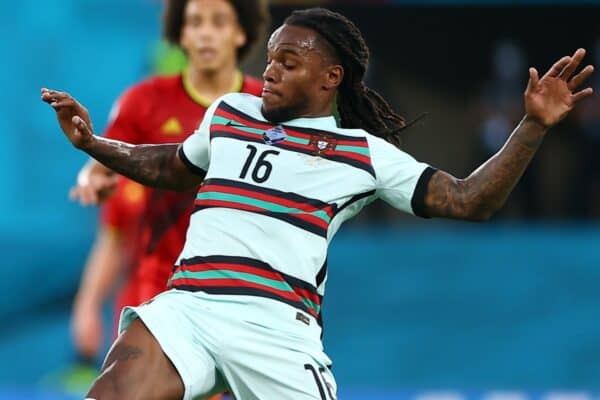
[104,85,147,144]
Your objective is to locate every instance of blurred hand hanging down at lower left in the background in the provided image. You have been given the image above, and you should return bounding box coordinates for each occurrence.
[71,305,103,359]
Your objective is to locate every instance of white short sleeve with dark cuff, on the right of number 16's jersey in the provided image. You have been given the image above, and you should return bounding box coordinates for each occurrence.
[369,138,436,218]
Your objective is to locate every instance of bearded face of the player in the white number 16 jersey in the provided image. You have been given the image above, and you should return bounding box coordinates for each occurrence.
[262,25,336,122]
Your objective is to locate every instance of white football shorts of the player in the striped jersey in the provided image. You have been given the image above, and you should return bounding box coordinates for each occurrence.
[119,289,336,400]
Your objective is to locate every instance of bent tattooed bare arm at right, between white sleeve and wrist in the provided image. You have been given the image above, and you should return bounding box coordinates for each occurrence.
[425,117,546,220]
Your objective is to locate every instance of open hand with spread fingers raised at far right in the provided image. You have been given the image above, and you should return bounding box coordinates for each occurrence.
[525,49,594,128]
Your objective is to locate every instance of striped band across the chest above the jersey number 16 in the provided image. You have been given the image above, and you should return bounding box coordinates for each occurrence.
[210,101,375,177]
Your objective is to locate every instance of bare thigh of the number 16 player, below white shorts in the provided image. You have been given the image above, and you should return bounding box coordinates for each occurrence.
[87,319,184,400]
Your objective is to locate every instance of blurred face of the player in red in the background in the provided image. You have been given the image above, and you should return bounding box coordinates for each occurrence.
[181,0,246,72]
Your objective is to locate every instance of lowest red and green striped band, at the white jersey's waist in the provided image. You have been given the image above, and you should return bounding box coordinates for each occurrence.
[169,256,323,320]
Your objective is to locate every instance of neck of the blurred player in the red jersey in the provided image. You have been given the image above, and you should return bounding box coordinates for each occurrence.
[186,61,239,103]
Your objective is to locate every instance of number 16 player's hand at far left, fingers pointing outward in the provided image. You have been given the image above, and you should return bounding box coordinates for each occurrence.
[42,88,94,149]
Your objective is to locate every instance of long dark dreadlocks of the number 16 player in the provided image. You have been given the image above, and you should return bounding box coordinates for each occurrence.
[285,8,406,146]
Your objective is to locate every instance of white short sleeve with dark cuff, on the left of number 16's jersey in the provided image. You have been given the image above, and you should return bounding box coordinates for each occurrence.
[179,99,222,175]
